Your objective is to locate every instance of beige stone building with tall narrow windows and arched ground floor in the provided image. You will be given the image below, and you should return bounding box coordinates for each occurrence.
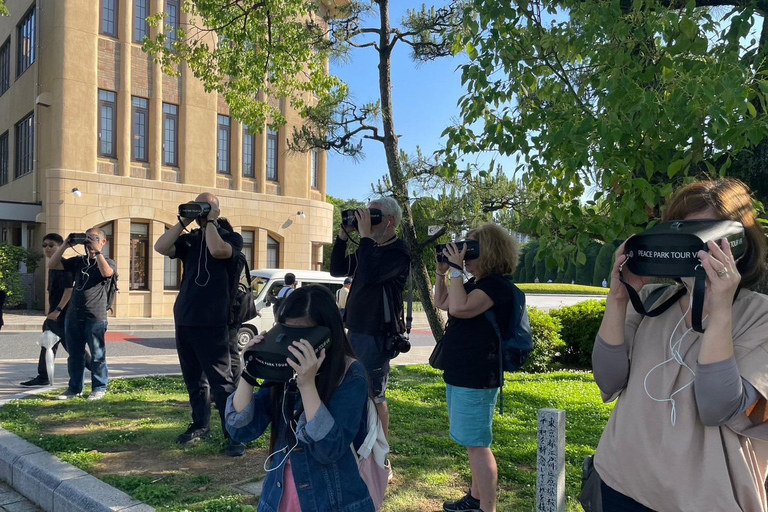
[0,0,333,317]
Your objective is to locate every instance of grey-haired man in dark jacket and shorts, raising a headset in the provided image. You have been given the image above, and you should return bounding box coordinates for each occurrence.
[331,197,411,436]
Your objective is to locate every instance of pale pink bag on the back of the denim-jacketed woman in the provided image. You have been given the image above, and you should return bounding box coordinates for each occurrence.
[351,398,390,510]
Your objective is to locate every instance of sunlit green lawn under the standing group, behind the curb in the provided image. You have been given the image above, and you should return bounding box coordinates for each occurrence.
[0,366,611,512]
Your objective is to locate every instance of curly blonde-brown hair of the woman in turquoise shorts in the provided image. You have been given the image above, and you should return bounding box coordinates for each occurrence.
[467,223,520,281]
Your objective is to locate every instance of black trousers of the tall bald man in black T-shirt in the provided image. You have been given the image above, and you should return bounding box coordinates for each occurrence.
[176,325,235,439]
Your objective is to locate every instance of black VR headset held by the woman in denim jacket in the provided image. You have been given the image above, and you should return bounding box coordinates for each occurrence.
[243,324,331,386]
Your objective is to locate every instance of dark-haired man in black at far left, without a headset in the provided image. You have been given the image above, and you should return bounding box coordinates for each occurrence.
[20,233,80,387]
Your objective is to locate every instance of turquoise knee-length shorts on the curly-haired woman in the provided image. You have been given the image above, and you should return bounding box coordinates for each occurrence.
[445,384,499,448]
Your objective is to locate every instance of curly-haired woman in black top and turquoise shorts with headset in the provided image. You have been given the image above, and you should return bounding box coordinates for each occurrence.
[435,224,519,512]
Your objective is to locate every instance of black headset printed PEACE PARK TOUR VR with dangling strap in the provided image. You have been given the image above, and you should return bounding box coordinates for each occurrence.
[619,220,747,332]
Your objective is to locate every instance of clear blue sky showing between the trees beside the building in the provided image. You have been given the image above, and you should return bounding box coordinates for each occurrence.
[327,0,466,200]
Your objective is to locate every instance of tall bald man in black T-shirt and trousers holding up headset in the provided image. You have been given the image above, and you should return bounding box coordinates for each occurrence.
[155,193,245,457]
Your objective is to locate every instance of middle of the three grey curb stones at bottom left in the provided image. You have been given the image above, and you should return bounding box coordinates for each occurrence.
[13,452,88,511]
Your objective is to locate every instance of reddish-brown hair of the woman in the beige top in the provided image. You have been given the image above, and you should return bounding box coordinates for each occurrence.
[662,178,767,288]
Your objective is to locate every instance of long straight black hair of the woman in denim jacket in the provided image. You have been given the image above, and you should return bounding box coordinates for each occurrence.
[269,286,355,453]
